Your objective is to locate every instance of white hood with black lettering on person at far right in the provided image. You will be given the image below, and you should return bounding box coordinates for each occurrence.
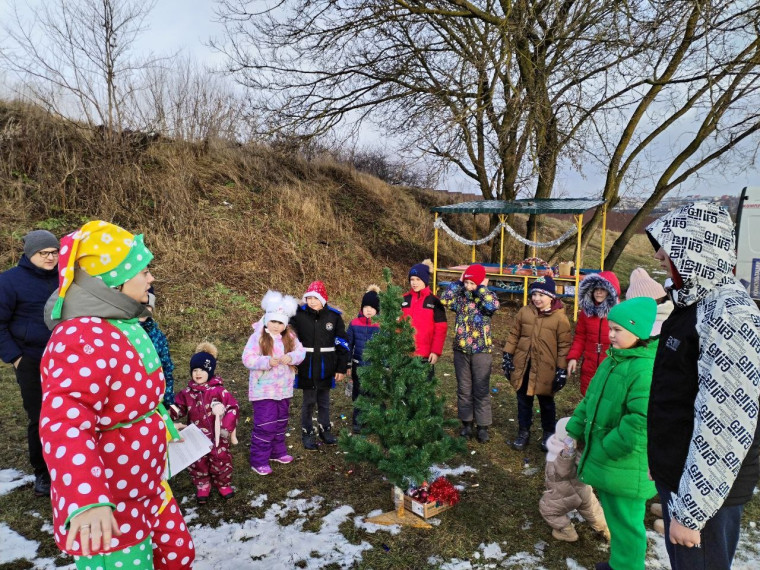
[647,202,736,307]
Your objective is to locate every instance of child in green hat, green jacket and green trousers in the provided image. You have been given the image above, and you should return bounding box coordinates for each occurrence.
[565,297,657,570]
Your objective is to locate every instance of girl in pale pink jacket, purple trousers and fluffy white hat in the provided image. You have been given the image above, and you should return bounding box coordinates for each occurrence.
[243,291,306,475]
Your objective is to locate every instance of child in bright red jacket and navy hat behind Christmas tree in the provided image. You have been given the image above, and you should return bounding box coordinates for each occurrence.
[401,259,448,365]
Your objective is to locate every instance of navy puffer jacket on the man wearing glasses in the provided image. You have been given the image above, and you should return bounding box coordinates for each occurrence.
[0,255,58,363]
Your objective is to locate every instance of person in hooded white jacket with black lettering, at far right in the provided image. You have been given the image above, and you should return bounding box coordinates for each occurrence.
[647,203,760,570]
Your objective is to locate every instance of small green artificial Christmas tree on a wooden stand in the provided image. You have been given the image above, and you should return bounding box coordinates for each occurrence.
[339,268,464,516]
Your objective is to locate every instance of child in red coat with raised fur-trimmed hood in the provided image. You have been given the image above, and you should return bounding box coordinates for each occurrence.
[567,271,620,396]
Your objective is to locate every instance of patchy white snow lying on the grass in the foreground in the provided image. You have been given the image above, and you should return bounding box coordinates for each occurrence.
[0,468,760,570]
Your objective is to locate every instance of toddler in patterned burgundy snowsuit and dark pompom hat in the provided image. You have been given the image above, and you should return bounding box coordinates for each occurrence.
[171,343,239,505]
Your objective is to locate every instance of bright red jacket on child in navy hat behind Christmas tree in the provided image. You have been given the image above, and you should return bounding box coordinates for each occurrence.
[401,287,449,358]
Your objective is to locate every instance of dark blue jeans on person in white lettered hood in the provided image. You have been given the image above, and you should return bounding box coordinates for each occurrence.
[655,481,744,570]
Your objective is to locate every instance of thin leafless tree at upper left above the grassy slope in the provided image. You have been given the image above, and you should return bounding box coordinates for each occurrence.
[0,0,156,138]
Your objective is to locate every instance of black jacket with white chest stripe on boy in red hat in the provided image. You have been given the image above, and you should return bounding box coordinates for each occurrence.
[290,305,348,390]
